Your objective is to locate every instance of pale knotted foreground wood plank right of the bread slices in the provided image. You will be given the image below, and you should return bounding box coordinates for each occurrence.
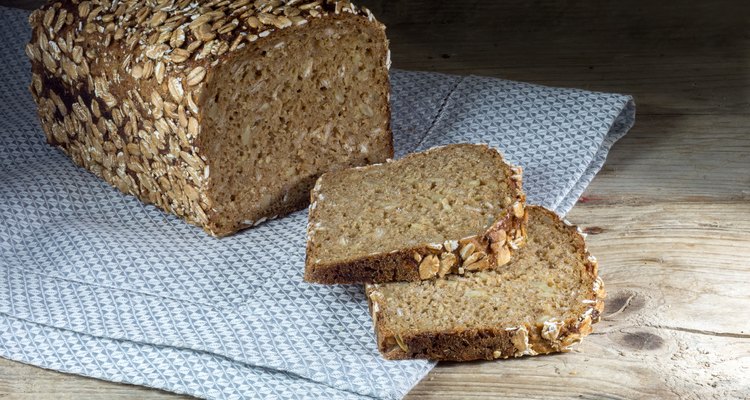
[407,202,750,399]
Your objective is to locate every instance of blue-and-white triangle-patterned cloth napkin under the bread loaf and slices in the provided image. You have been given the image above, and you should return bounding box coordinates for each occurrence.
[0,8,635,399]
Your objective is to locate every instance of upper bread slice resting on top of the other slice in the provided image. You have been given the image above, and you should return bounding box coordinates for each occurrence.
[305,144,525,284]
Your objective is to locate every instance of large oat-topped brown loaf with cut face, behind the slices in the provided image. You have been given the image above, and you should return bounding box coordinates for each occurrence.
[26,0,393,236]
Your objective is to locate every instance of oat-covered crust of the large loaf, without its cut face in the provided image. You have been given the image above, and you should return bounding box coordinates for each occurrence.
[26,0,393,236]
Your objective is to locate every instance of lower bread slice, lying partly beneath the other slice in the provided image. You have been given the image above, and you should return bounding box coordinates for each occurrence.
[365,206,605,361]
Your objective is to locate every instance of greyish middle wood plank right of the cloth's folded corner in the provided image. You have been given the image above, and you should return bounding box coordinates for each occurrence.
[584,115,750,205]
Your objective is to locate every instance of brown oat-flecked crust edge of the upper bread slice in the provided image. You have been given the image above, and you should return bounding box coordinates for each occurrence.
[304,145,528,284]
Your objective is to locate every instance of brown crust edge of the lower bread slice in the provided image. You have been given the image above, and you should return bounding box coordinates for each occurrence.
[366,206,606,361]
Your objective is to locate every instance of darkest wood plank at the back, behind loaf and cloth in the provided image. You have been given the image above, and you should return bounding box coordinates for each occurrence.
[364,0,750,115]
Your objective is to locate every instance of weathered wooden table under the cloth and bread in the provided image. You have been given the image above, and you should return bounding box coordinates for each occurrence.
[0,0,750,400]
